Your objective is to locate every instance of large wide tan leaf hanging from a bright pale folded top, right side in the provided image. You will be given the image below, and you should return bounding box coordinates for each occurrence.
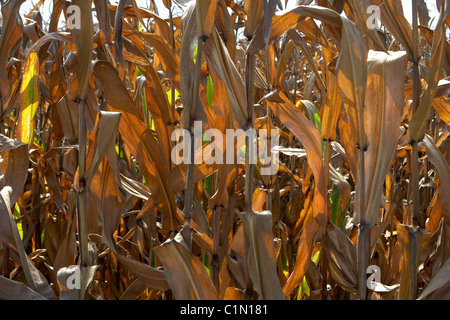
[355,50,406,226]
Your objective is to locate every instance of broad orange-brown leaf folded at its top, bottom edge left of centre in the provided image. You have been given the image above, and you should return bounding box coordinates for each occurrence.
[154,233,218,300]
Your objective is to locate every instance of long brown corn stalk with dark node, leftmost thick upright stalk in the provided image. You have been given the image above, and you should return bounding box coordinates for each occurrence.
[77,100,89,300]
